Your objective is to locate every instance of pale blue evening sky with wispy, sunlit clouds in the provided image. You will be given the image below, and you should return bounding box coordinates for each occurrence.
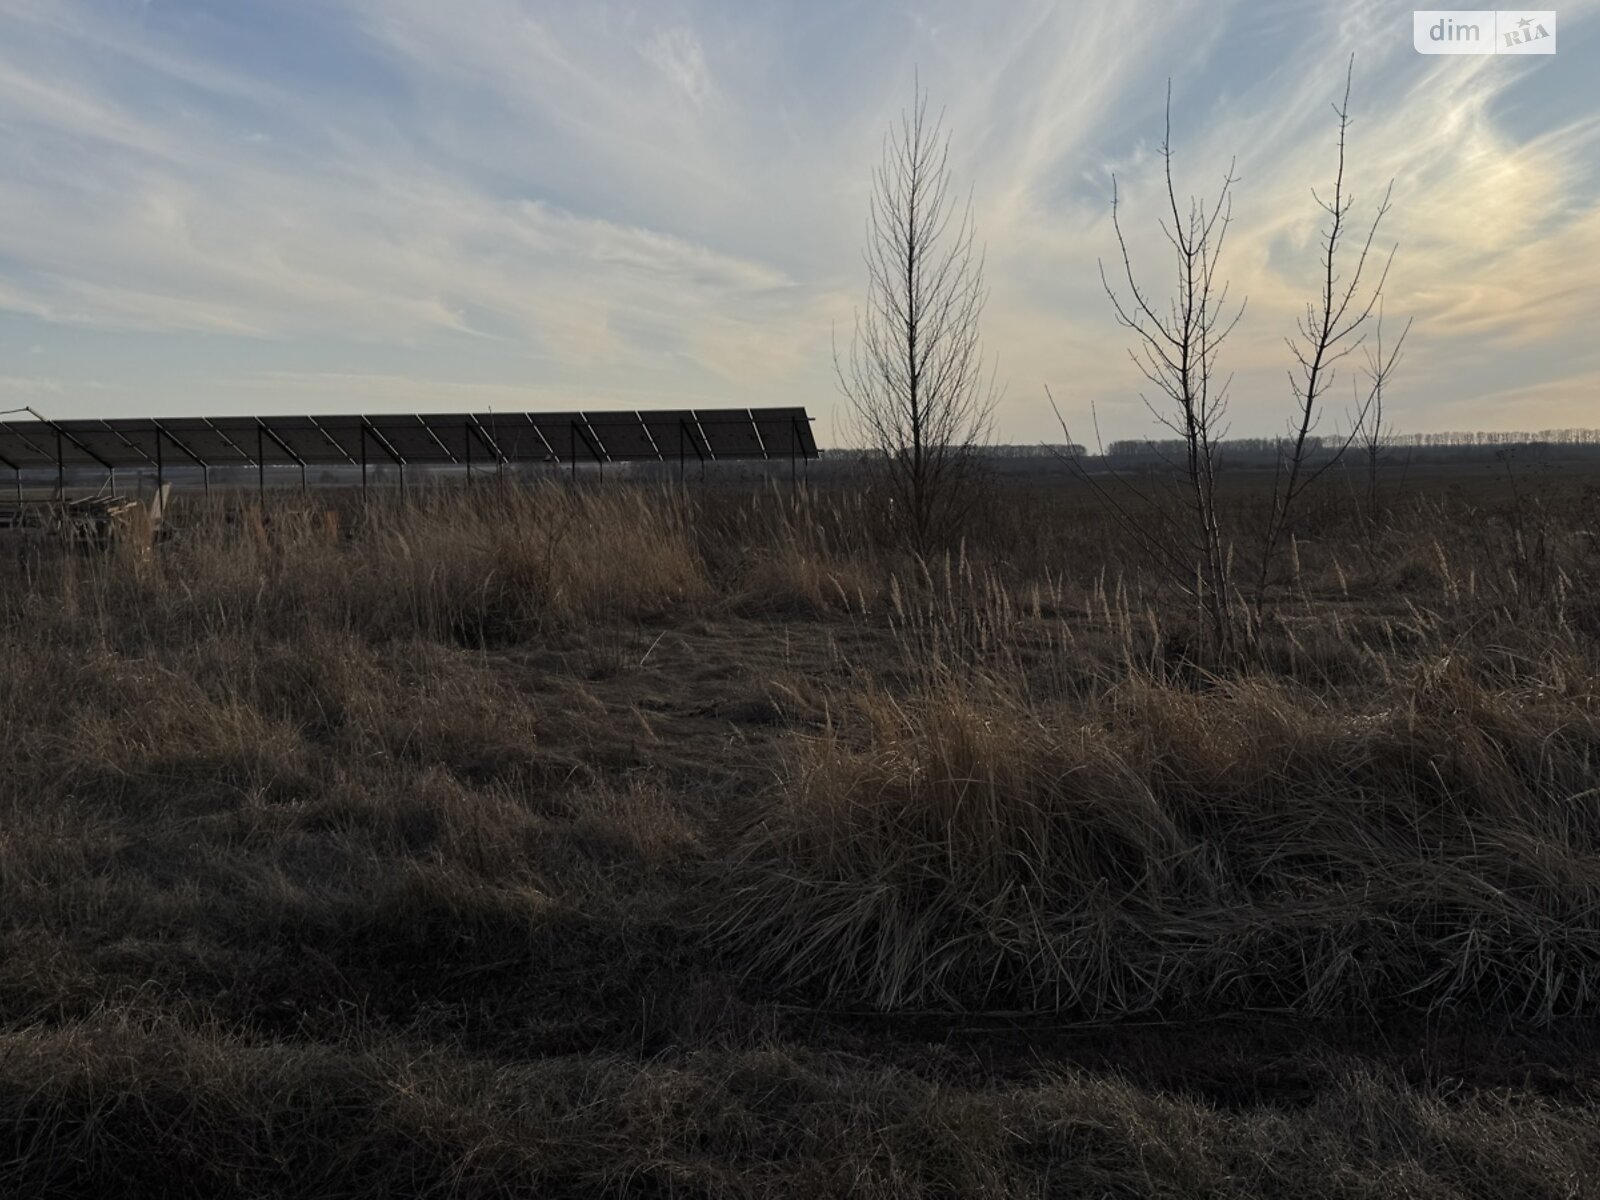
[0,0,1600,445]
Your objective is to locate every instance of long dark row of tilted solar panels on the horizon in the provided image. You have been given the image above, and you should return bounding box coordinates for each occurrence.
[0,408,816,472]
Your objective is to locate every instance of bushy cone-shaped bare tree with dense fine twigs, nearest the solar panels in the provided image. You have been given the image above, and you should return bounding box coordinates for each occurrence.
[834,85,998,552]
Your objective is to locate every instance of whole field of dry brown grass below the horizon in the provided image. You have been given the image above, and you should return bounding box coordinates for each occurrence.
[0,467,1600,1200]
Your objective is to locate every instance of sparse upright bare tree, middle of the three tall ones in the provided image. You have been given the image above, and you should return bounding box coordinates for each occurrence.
[1101,83,1245,650]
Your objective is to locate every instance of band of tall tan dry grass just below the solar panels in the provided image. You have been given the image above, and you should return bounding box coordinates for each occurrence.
[0,485,709,643]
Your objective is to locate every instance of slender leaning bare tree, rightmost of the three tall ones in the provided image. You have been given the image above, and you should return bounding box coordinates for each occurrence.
[1256,56,1403,611]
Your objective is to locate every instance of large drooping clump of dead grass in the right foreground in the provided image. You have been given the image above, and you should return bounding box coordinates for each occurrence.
[718,664,1600,1021]
